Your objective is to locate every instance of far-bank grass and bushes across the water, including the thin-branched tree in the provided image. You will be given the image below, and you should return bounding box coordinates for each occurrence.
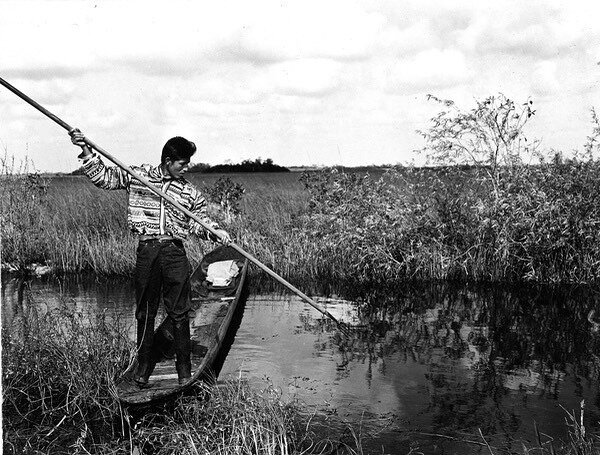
[0,95,600,284]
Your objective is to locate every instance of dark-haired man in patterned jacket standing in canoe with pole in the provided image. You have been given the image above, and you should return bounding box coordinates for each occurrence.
[69,129,231,387]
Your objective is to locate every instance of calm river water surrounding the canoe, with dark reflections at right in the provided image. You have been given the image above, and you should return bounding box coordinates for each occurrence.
[2,274,600,454]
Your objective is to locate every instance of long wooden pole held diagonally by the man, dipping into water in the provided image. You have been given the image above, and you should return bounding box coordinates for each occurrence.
[0,77,346,331]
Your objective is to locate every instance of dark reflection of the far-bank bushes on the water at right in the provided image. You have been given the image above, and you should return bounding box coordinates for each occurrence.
[352,284,598,382]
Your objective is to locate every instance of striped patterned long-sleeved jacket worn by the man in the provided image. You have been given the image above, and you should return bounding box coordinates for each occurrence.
[83,154,218,240]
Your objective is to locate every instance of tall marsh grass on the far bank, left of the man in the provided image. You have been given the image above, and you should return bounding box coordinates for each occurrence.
[0,158,135,274]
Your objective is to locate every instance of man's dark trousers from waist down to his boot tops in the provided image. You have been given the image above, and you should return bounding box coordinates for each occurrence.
[134,240,191,322]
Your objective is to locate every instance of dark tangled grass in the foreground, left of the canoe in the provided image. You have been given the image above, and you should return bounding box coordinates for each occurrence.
[2,282,132,453]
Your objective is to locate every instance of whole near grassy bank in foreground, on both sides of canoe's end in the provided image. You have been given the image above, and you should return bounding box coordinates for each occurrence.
[2,292,360,454]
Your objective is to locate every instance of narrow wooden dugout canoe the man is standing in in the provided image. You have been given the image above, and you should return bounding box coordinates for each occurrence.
[116,246,248,406]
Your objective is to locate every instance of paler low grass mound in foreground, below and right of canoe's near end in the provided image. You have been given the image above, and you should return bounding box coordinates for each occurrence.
[133,380,360,455]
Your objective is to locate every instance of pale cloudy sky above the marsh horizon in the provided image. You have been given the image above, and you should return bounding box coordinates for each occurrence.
[0,0,600,172]
